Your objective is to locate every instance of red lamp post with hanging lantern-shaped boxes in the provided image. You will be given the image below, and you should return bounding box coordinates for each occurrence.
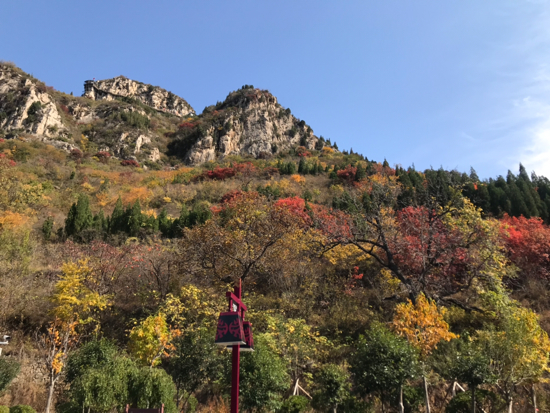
[215,279,254,413]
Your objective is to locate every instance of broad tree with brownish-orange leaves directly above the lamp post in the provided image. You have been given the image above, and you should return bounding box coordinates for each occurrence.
[180,191,310,283]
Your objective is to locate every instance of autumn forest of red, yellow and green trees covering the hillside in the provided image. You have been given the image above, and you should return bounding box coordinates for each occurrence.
[0,136,550,413]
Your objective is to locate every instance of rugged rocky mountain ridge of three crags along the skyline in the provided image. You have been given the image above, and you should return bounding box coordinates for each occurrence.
[0,63,332,165]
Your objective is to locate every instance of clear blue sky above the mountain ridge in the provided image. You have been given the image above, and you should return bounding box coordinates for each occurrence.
[0,0,550,178]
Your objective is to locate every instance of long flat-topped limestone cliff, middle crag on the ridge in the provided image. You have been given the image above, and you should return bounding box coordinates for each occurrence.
[83,76,195,117]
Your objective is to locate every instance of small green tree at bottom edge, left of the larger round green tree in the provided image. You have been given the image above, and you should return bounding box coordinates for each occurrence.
[313,364,350,413]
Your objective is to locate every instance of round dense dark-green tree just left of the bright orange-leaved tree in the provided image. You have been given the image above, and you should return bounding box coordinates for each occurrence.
[350,324,419,413]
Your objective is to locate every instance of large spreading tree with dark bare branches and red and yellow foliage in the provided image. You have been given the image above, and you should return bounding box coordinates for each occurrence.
[313,174,506,310]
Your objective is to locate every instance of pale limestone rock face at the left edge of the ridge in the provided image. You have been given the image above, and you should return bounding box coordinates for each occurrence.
[0,65,66,137]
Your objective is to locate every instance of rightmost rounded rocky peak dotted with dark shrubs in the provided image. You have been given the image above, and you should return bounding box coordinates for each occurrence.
[170,87,318,165]
